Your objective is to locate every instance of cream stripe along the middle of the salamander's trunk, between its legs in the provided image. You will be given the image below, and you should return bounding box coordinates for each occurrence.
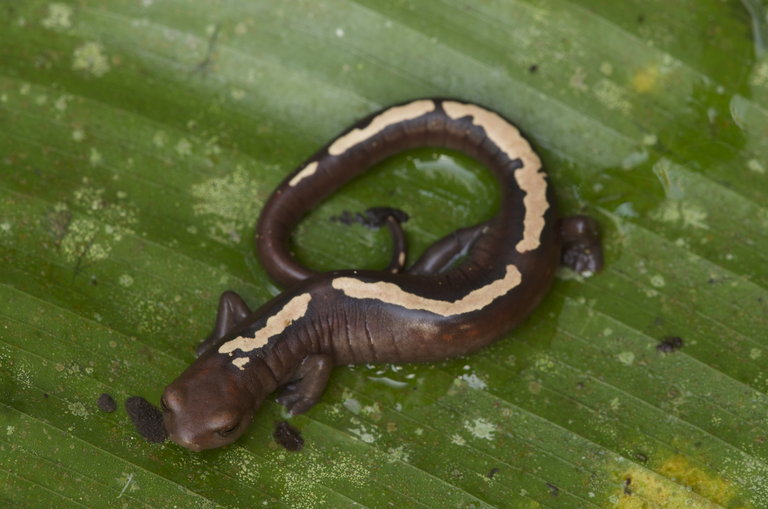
[331,265,522,316]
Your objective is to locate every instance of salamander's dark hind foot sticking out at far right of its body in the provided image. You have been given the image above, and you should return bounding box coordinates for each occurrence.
[560,216,603,275]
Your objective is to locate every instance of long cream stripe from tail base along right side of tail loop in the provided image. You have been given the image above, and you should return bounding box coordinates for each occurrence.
[443,101,549,253]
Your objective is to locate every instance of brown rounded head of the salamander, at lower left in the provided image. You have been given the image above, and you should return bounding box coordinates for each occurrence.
[160,356,264,451]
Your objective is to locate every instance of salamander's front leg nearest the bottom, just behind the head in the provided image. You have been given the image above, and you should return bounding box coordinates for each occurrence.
[277,354,333,415]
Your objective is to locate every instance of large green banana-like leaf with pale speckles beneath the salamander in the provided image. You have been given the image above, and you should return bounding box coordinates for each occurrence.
[0,0,768,508]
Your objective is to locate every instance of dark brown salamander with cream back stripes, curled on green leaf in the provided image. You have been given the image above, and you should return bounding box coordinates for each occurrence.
[161,98,602,451]
